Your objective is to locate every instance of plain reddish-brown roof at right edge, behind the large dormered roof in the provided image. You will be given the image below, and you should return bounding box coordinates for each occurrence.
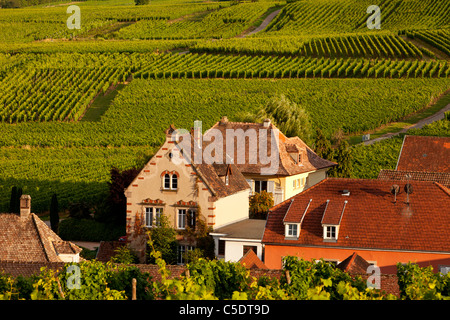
[396,136,450,173]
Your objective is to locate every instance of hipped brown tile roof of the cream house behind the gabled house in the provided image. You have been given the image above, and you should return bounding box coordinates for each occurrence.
[205,119,337,176]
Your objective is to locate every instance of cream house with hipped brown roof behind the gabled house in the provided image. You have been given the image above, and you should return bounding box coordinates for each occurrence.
[205,117,337,204]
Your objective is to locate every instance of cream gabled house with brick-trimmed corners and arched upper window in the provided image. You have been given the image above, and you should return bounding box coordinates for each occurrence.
[125,126,249,263]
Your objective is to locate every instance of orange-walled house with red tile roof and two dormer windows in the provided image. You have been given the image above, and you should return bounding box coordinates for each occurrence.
[262,178,450,274]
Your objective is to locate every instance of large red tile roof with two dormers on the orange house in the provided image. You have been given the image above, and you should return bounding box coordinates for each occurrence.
[263,178,450,252]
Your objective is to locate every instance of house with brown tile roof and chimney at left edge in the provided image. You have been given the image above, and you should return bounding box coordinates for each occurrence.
[0,195,82,263]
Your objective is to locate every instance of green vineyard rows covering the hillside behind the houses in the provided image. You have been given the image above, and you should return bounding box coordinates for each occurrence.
[0,0,450,212]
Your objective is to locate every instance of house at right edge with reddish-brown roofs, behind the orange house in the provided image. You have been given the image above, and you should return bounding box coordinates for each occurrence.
[378,136,450,187]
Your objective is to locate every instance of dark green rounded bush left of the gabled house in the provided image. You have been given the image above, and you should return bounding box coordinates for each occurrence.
[59,218,125,241]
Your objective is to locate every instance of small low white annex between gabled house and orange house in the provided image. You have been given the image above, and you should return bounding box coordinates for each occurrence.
[210,219,266,261]
